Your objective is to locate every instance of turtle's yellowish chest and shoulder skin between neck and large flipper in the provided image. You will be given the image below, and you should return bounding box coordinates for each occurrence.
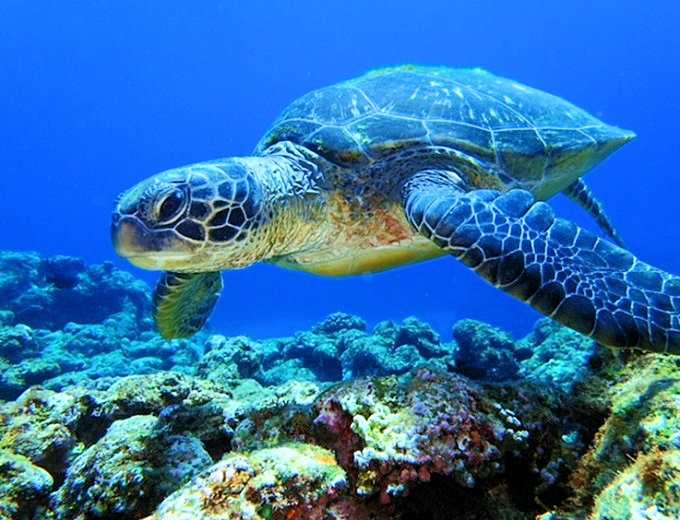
[263,143,510,276]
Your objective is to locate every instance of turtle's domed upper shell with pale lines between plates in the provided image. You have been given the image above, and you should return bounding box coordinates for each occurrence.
[256,66,635,193]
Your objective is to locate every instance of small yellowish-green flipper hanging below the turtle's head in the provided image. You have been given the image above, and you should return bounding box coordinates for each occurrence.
[153,272,222,339]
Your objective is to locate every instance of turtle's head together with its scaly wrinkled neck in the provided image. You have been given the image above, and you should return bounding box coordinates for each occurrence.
[112,146,330,273]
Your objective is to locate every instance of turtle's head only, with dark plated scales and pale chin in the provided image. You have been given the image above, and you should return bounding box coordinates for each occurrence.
[111,158,263,272]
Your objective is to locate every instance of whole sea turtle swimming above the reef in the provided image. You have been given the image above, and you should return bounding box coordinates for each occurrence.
[112,66,680,352]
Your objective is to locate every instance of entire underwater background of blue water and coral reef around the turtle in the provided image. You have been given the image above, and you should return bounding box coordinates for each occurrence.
[0,4,680,520]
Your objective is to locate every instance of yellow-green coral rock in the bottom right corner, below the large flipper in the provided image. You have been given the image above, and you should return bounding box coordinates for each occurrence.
[544,354,680,520]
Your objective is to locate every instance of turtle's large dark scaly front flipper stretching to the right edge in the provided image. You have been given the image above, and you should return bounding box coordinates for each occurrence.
[403,172,680,353]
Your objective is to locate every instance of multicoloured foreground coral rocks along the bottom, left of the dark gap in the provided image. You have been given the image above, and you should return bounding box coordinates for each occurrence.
[0,369,572,519]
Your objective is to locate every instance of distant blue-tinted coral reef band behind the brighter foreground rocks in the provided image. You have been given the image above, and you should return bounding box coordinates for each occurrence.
[0,253,594,399]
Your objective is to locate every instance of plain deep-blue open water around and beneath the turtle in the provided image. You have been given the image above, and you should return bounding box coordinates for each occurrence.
[0,0,680,337]
